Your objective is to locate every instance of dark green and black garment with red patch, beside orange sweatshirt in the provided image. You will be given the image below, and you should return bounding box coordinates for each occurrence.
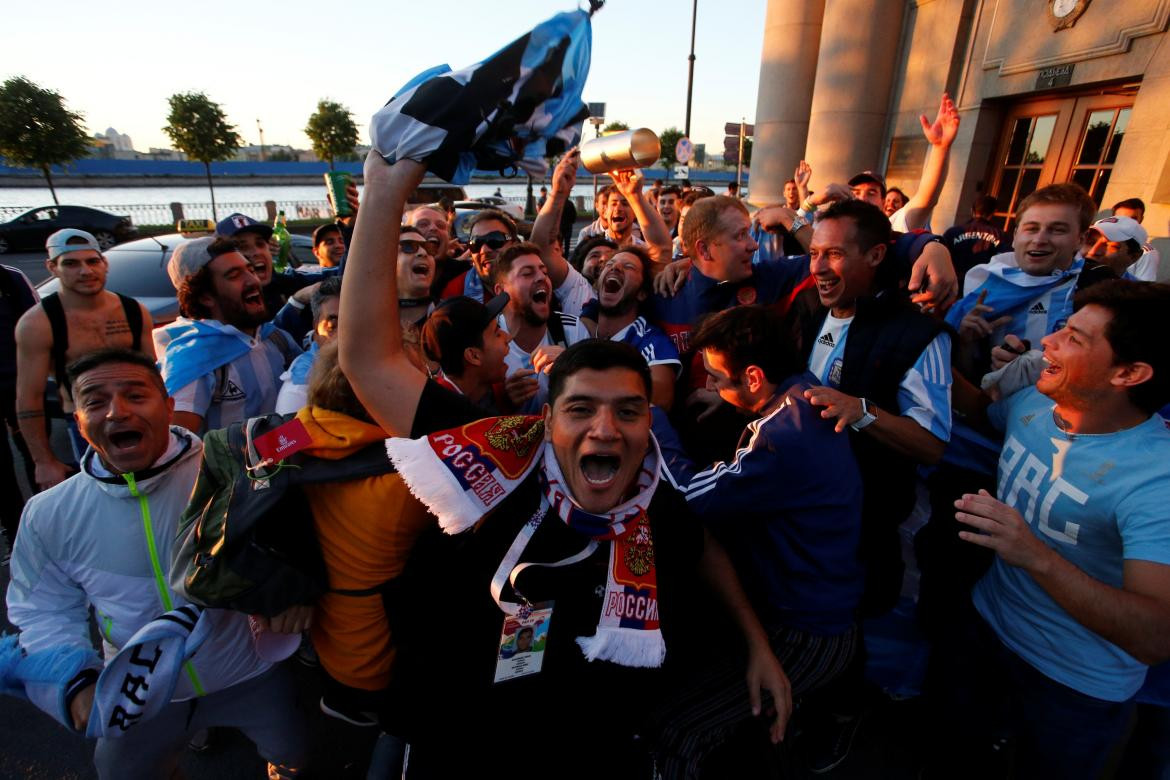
[171,414,394,617]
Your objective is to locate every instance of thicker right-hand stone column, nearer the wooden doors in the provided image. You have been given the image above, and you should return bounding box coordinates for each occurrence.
[805,0,906,189]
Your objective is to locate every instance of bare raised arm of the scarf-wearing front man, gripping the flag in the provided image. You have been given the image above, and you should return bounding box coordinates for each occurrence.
[338,151,426,436]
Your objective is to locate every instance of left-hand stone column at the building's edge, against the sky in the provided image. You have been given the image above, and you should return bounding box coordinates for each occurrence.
[748,0,825,206]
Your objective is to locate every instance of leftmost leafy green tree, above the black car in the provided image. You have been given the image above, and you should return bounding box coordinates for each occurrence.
[0,76,90,203]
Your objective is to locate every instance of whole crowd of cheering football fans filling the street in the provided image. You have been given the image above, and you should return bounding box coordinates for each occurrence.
[0,88,1170,778]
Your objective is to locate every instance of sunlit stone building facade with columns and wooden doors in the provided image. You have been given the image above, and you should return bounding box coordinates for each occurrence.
[751,0,1170,265]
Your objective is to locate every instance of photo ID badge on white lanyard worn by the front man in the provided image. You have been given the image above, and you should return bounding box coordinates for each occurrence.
[491,495,597,683]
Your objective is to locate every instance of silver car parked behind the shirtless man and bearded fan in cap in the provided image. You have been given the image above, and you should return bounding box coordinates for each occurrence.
[36,233,317,327]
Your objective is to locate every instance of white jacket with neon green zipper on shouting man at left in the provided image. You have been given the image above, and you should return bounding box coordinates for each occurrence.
[8,427,271,723]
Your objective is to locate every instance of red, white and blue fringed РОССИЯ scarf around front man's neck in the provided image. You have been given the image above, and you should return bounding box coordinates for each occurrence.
[386,415,666,667]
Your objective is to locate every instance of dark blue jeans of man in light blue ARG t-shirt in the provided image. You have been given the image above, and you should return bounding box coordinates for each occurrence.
[928,605,1134,779]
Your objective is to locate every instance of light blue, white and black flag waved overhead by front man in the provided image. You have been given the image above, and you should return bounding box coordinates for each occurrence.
[370,2,600,185]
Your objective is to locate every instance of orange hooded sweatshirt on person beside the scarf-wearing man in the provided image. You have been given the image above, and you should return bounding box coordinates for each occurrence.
[297,406,435,690]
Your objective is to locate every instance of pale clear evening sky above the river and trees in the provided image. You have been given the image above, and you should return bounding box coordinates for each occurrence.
[0,0,765,152]
